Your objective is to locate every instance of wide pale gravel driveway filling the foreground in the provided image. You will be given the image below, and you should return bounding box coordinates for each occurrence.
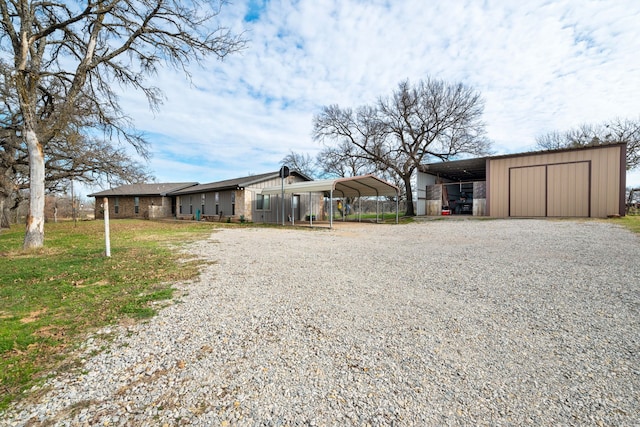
[0,220,640,426]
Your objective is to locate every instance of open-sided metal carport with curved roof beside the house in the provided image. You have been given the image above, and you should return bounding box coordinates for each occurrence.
[261,175,400,227]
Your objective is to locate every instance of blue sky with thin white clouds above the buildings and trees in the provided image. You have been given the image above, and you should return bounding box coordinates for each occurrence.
[90,0,640,194]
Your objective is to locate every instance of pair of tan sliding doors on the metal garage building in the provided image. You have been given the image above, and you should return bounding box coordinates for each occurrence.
[509,162,591,217]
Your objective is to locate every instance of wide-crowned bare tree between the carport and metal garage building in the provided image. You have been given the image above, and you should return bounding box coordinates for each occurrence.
[313,78,490,216]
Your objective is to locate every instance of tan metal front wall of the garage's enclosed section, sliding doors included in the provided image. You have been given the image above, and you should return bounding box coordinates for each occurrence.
[487,145,624,217]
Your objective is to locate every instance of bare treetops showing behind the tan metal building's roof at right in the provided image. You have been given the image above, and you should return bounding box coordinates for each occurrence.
[536,118,640,170]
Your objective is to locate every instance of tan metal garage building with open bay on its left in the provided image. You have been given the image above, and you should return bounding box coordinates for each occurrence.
[417,144,626,217]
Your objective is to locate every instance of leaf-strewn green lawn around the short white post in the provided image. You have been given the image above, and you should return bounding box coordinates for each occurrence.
[0,220,215,411]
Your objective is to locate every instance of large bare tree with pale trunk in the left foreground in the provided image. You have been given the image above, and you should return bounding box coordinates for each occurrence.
[0,0,245,248]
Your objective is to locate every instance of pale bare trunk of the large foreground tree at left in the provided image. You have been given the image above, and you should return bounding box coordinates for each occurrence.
[23,130,44,249]
